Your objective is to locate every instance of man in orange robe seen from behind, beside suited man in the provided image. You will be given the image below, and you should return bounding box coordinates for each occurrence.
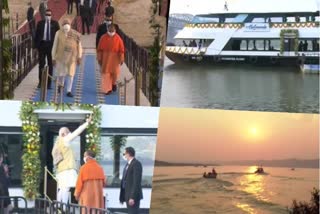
[74,150,106,208]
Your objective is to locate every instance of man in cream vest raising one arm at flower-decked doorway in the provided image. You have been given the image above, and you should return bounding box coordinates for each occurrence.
[52,117,91,203]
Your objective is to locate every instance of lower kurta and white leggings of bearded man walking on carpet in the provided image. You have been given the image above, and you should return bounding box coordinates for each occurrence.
[56,62,77,92]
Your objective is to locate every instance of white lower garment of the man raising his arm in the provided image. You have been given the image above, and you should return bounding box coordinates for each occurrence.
[56,169,78,203]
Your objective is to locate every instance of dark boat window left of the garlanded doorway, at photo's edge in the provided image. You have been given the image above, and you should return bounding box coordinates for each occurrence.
[0,134,23,186]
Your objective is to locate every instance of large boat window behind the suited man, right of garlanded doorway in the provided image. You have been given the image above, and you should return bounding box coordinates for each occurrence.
[100,135,157,187]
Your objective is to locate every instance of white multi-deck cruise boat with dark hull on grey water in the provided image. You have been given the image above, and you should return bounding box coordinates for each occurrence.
[166,0,320,65]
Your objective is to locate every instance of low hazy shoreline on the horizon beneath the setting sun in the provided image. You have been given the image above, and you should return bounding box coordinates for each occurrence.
[154,159,319,169]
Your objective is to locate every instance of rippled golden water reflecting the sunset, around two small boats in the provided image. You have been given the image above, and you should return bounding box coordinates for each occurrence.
[152,166,319,214]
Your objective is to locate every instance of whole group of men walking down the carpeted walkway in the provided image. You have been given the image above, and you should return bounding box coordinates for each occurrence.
[27,0,125,97]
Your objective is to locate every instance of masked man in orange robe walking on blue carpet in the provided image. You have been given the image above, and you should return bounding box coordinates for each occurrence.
[97,24,124,95]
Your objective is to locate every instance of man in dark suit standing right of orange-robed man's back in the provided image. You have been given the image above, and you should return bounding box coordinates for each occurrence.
[120,147,143,214]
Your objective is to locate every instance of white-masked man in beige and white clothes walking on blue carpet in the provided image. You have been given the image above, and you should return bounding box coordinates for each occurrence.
[52,19,82,97]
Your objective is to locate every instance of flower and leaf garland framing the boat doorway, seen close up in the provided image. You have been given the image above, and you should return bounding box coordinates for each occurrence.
[20,101,101,200]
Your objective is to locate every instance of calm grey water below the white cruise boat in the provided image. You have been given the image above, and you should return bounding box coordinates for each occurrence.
[161,58,319,113]
